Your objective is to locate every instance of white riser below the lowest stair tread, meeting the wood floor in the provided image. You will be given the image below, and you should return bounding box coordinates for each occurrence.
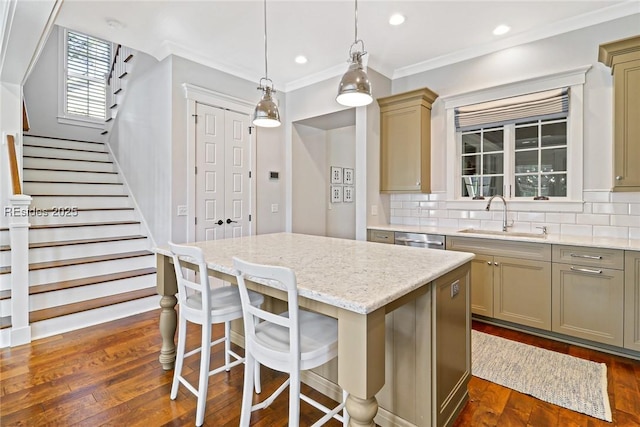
[31,296,160,342]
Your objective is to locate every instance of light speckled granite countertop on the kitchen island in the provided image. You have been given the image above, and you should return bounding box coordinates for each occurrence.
[155,233,474,314]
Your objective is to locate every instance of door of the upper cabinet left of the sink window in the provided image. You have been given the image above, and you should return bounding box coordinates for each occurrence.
[380,104,431,192]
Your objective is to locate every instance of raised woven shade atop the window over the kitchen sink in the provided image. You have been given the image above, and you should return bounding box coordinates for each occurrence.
[455,88,569,131]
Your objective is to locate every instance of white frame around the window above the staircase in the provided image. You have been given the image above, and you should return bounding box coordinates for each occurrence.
[58,28,114,129]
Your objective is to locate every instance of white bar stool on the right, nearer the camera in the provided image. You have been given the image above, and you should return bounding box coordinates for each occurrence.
[233,257,348,427]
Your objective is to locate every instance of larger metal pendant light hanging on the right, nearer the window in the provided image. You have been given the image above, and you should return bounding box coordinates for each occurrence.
[336,0,373,107]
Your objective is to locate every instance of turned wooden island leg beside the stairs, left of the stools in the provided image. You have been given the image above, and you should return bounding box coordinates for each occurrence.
[156,254,178,371]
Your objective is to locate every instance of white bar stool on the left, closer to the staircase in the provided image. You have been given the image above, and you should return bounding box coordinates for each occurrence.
[169,242,264,426]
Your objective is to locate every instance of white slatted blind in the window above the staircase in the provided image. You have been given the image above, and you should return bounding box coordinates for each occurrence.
[65,31,111,120]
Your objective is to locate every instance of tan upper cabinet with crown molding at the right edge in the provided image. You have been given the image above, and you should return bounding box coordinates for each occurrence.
[598,36,640,191]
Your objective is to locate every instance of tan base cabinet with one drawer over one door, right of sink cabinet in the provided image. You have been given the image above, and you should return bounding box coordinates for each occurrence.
[552,245,624,347]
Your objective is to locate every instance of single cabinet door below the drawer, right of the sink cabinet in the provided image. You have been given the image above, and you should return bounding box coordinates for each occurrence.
[552,264,624,347]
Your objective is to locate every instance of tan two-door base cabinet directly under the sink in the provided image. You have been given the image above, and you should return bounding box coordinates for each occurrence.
[447,237,551,330]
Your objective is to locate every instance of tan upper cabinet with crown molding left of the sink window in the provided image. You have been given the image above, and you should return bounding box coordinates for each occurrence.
[378,88,438,193]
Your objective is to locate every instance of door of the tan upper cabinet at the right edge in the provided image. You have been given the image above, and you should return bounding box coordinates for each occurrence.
[613,58,640,191]
